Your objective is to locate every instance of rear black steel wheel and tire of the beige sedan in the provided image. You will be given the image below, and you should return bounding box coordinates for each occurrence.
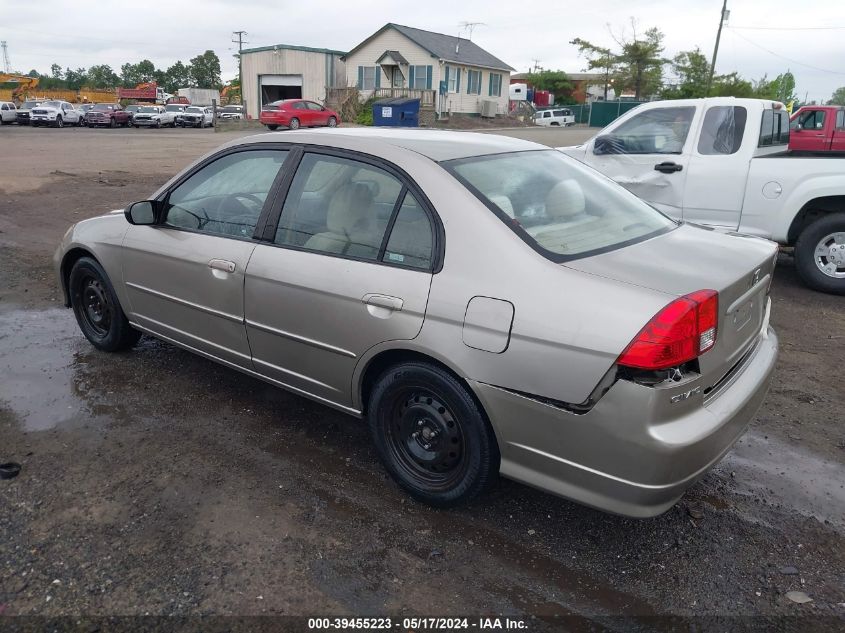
[367,362,499,507]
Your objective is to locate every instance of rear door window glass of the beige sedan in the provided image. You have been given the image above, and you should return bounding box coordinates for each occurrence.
[275,154,432,268]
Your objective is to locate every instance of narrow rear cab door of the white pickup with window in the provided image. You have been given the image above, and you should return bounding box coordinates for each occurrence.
[683,105,757,230]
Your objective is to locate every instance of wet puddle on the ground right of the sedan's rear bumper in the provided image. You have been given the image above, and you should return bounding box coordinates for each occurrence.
[719,431,845,531]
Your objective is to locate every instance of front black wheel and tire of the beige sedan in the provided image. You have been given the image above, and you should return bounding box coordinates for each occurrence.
[68,257,141,352]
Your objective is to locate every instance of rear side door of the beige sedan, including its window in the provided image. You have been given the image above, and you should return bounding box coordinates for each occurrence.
[244,150,440,407]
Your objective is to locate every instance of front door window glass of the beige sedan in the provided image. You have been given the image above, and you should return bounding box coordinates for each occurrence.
[165,150,287,238]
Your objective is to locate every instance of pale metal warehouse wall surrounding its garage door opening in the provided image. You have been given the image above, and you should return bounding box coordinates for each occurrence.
[242,48,346,118]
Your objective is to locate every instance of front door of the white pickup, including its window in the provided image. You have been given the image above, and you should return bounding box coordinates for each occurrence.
[584,105,698,218]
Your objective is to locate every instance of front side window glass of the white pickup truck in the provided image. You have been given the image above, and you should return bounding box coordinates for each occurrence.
[593,106,695,154]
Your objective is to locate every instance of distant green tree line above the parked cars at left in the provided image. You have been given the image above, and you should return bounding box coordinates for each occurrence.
[16,50,222,93]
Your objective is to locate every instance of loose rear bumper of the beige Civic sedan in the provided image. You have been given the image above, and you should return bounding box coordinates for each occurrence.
[472,327,778,517]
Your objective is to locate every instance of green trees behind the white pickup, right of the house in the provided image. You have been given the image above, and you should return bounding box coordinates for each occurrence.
[529,19,845,105]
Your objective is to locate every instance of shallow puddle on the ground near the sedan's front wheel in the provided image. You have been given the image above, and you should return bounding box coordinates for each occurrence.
[0,309,90,431]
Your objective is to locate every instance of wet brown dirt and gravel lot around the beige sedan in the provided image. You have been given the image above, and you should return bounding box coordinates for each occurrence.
[0,127,845,630]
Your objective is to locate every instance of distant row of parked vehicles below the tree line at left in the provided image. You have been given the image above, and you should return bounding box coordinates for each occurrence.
[0,100,237,128]
